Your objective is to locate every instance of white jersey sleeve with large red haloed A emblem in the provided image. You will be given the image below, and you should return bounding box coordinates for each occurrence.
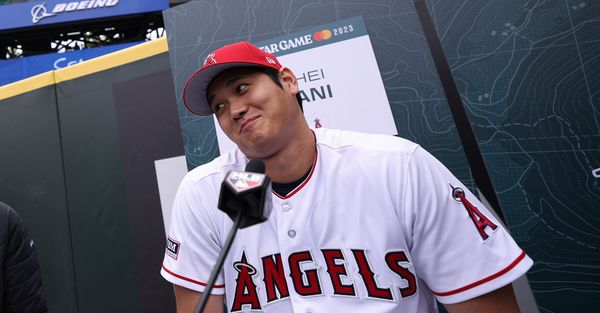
[404,147,533,303]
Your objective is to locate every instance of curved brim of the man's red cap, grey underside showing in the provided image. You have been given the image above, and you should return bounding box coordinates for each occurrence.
[183,62,265,116]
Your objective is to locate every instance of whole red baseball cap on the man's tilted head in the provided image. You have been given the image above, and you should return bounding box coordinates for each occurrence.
[183,41,283,115]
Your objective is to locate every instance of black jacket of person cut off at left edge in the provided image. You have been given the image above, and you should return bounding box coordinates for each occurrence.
[0,202,48,313]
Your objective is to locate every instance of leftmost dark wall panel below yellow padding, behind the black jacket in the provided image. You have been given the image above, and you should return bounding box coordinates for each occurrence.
[0,73,78,313]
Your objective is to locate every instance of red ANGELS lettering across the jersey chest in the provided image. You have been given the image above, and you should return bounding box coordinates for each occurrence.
[231,249,417,312]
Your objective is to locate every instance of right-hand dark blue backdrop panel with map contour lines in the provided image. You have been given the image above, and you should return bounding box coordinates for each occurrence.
[428,0,600,312]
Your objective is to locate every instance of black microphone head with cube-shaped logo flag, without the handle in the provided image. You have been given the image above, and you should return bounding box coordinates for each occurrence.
[218,160,272,228]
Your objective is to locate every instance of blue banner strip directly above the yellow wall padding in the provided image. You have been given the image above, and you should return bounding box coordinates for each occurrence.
[0,41,141,86]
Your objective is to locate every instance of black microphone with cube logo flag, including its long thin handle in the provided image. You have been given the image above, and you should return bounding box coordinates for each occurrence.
[194,160,273,313]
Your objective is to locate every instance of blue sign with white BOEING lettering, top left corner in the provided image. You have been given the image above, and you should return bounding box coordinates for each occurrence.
[0,0,169,30]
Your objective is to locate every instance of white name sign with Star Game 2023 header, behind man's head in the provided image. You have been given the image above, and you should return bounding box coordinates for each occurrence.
[215,17,397,153]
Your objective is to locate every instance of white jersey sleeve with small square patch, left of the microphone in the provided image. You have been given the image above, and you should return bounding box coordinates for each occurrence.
[160,174,225,295]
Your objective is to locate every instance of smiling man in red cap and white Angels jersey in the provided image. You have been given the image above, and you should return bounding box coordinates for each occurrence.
[161,42,533,313]
